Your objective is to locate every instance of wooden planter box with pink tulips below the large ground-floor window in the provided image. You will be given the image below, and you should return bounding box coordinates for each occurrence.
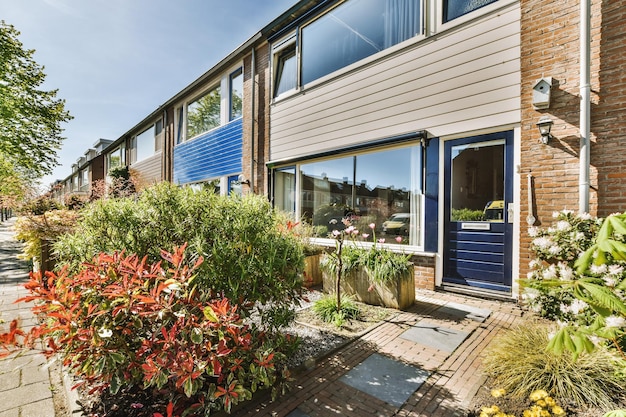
[323,265,415,310]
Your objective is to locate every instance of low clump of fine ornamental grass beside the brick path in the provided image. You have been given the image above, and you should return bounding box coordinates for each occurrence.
[483,321,626,407]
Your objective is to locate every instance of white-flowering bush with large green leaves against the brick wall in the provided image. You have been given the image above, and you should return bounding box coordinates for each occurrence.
[520,211,626,358]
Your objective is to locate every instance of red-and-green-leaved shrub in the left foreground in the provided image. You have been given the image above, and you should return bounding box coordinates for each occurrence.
[0,247,291,415]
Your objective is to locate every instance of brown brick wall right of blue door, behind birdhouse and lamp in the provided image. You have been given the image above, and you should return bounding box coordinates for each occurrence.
[520,0,626,276]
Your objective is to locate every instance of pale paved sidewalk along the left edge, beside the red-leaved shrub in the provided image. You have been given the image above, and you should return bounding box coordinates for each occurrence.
[0,218,62,417]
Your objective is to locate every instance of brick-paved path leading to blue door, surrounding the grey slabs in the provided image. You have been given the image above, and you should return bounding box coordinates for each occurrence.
[235,291,522,417]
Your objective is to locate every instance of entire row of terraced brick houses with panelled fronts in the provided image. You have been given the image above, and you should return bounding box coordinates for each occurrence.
[48,0,626,298]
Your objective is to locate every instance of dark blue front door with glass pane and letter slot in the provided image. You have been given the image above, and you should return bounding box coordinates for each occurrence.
[443,131,513,292]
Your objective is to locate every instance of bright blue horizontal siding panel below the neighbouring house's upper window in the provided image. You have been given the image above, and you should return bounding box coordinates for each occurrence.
[174,118,243,184]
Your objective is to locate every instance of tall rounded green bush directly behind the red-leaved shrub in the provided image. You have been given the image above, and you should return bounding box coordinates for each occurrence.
[55,183,304,327]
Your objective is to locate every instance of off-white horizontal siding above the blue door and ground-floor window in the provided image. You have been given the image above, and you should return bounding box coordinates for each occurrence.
[270,4,520,160]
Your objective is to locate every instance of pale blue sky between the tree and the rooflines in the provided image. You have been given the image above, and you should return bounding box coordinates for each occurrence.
[0,0,297,186]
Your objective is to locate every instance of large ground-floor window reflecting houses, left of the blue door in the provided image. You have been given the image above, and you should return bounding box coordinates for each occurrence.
[274,145,422,246]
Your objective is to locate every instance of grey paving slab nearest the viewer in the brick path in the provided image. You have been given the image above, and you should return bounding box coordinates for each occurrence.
[340,353,430,407]
